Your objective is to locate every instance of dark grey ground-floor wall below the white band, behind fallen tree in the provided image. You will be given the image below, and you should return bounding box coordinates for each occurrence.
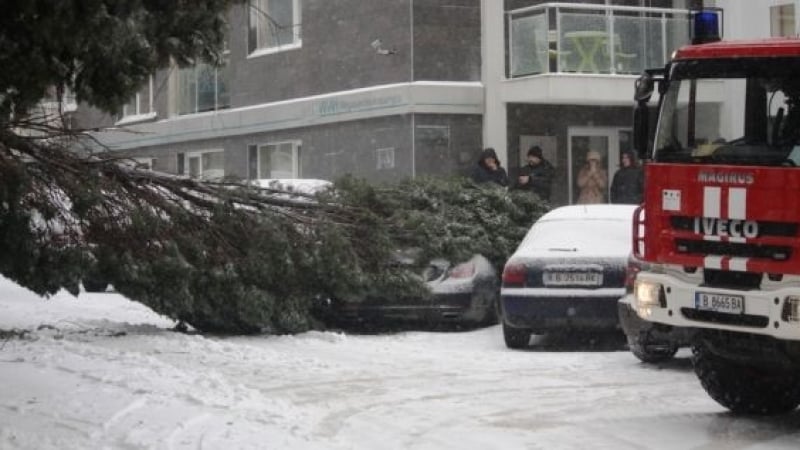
[119,114,482,181]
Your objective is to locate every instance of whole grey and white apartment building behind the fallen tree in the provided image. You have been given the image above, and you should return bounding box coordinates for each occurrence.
[78,0,736,204]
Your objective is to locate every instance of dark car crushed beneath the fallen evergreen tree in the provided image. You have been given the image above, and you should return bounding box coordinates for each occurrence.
[320,255,499,327]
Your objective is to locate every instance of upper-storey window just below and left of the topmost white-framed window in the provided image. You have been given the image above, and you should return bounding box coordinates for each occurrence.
[177,61,231,115]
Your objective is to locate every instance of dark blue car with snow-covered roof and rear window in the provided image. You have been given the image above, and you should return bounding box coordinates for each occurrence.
[500,204,635,348]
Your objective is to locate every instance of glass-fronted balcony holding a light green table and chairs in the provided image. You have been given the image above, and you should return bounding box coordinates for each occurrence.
[506,3,689,79]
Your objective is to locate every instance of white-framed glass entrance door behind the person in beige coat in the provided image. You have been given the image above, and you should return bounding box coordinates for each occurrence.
[567,127,632,203]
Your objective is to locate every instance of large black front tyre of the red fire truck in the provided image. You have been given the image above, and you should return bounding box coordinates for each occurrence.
[692,343,800,415]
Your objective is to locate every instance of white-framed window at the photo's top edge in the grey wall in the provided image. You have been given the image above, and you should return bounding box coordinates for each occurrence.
[247,0,301,54]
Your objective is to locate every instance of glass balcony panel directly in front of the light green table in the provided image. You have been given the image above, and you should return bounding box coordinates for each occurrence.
[558,11,611,73]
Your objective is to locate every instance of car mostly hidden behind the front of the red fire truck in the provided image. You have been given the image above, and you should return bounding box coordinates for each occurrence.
[617,255,690,363]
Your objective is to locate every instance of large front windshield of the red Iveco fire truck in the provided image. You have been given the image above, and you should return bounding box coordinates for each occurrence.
[654,58,800,167]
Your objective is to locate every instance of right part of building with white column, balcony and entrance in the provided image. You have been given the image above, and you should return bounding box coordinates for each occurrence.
[483,0,704,204]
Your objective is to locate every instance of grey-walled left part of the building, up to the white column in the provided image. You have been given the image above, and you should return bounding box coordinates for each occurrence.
[79,0,483,180]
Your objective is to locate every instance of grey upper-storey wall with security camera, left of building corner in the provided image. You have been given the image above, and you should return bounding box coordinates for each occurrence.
[225,0,412,108]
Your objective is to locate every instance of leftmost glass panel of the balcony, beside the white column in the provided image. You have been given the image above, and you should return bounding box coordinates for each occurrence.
[511,14,550,77]
